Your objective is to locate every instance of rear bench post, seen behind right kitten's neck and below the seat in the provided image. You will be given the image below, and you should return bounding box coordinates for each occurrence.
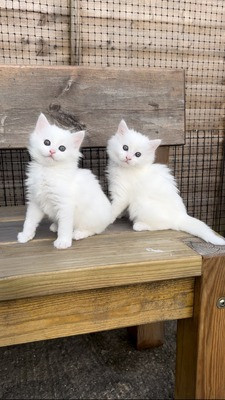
[128,146,169,350]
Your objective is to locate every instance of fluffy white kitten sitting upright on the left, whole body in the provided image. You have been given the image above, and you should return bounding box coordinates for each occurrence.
[18,114,112,249]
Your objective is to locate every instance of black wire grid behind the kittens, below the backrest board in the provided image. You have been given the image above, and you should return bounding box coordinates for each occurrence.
[0,131,225,234]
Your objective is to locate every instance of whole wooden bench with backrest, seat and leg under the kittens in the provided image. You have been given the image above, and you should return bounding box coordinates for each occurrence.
[0,67,225,399]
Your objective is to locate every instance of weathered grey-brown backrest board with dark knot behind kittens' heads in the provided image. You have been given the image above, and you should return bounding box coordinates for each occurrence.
[0,66,185,148]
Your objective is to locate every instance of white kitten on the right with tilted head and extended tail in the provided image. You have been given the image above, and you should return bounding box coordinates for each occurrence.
[107,120,225,245]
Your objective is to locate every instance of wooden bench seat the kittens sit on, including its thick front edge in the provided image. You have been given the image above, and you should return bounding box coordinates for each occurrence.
[0,208,202,300]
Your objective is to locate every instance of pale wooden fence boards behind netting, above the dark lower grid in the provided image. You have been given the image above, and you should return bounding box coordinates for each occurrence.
[0,0,224,130]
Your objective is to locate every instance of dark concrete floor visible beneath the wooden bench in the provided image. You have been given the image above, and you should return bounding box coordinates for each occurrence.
[0,322,176,399]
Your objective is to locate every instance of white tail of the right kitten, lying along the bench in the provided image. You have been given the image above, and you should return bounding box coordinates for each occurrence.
[179,215,225,245]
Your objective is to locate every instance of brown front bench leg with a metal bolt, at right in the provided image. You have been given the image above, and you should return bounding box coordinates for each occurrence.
[176,254,225,399]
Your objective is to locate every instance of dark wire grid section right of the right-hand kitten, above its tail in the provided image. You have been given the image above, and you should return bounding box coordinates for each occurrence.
[170,130,225,234]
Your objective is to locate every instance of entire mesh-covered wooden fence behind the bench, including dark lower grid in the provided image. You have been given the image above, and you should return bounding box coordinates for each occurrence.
[0,0,225,233]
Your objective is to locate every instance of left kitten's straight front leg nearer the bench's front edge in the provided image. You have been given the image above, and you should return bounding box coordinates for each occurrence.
[54,205,73,249]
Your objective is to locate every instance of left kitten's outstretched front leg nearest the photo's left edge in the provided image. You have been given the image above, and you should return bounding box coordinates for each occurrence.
[17,202,44,243]
